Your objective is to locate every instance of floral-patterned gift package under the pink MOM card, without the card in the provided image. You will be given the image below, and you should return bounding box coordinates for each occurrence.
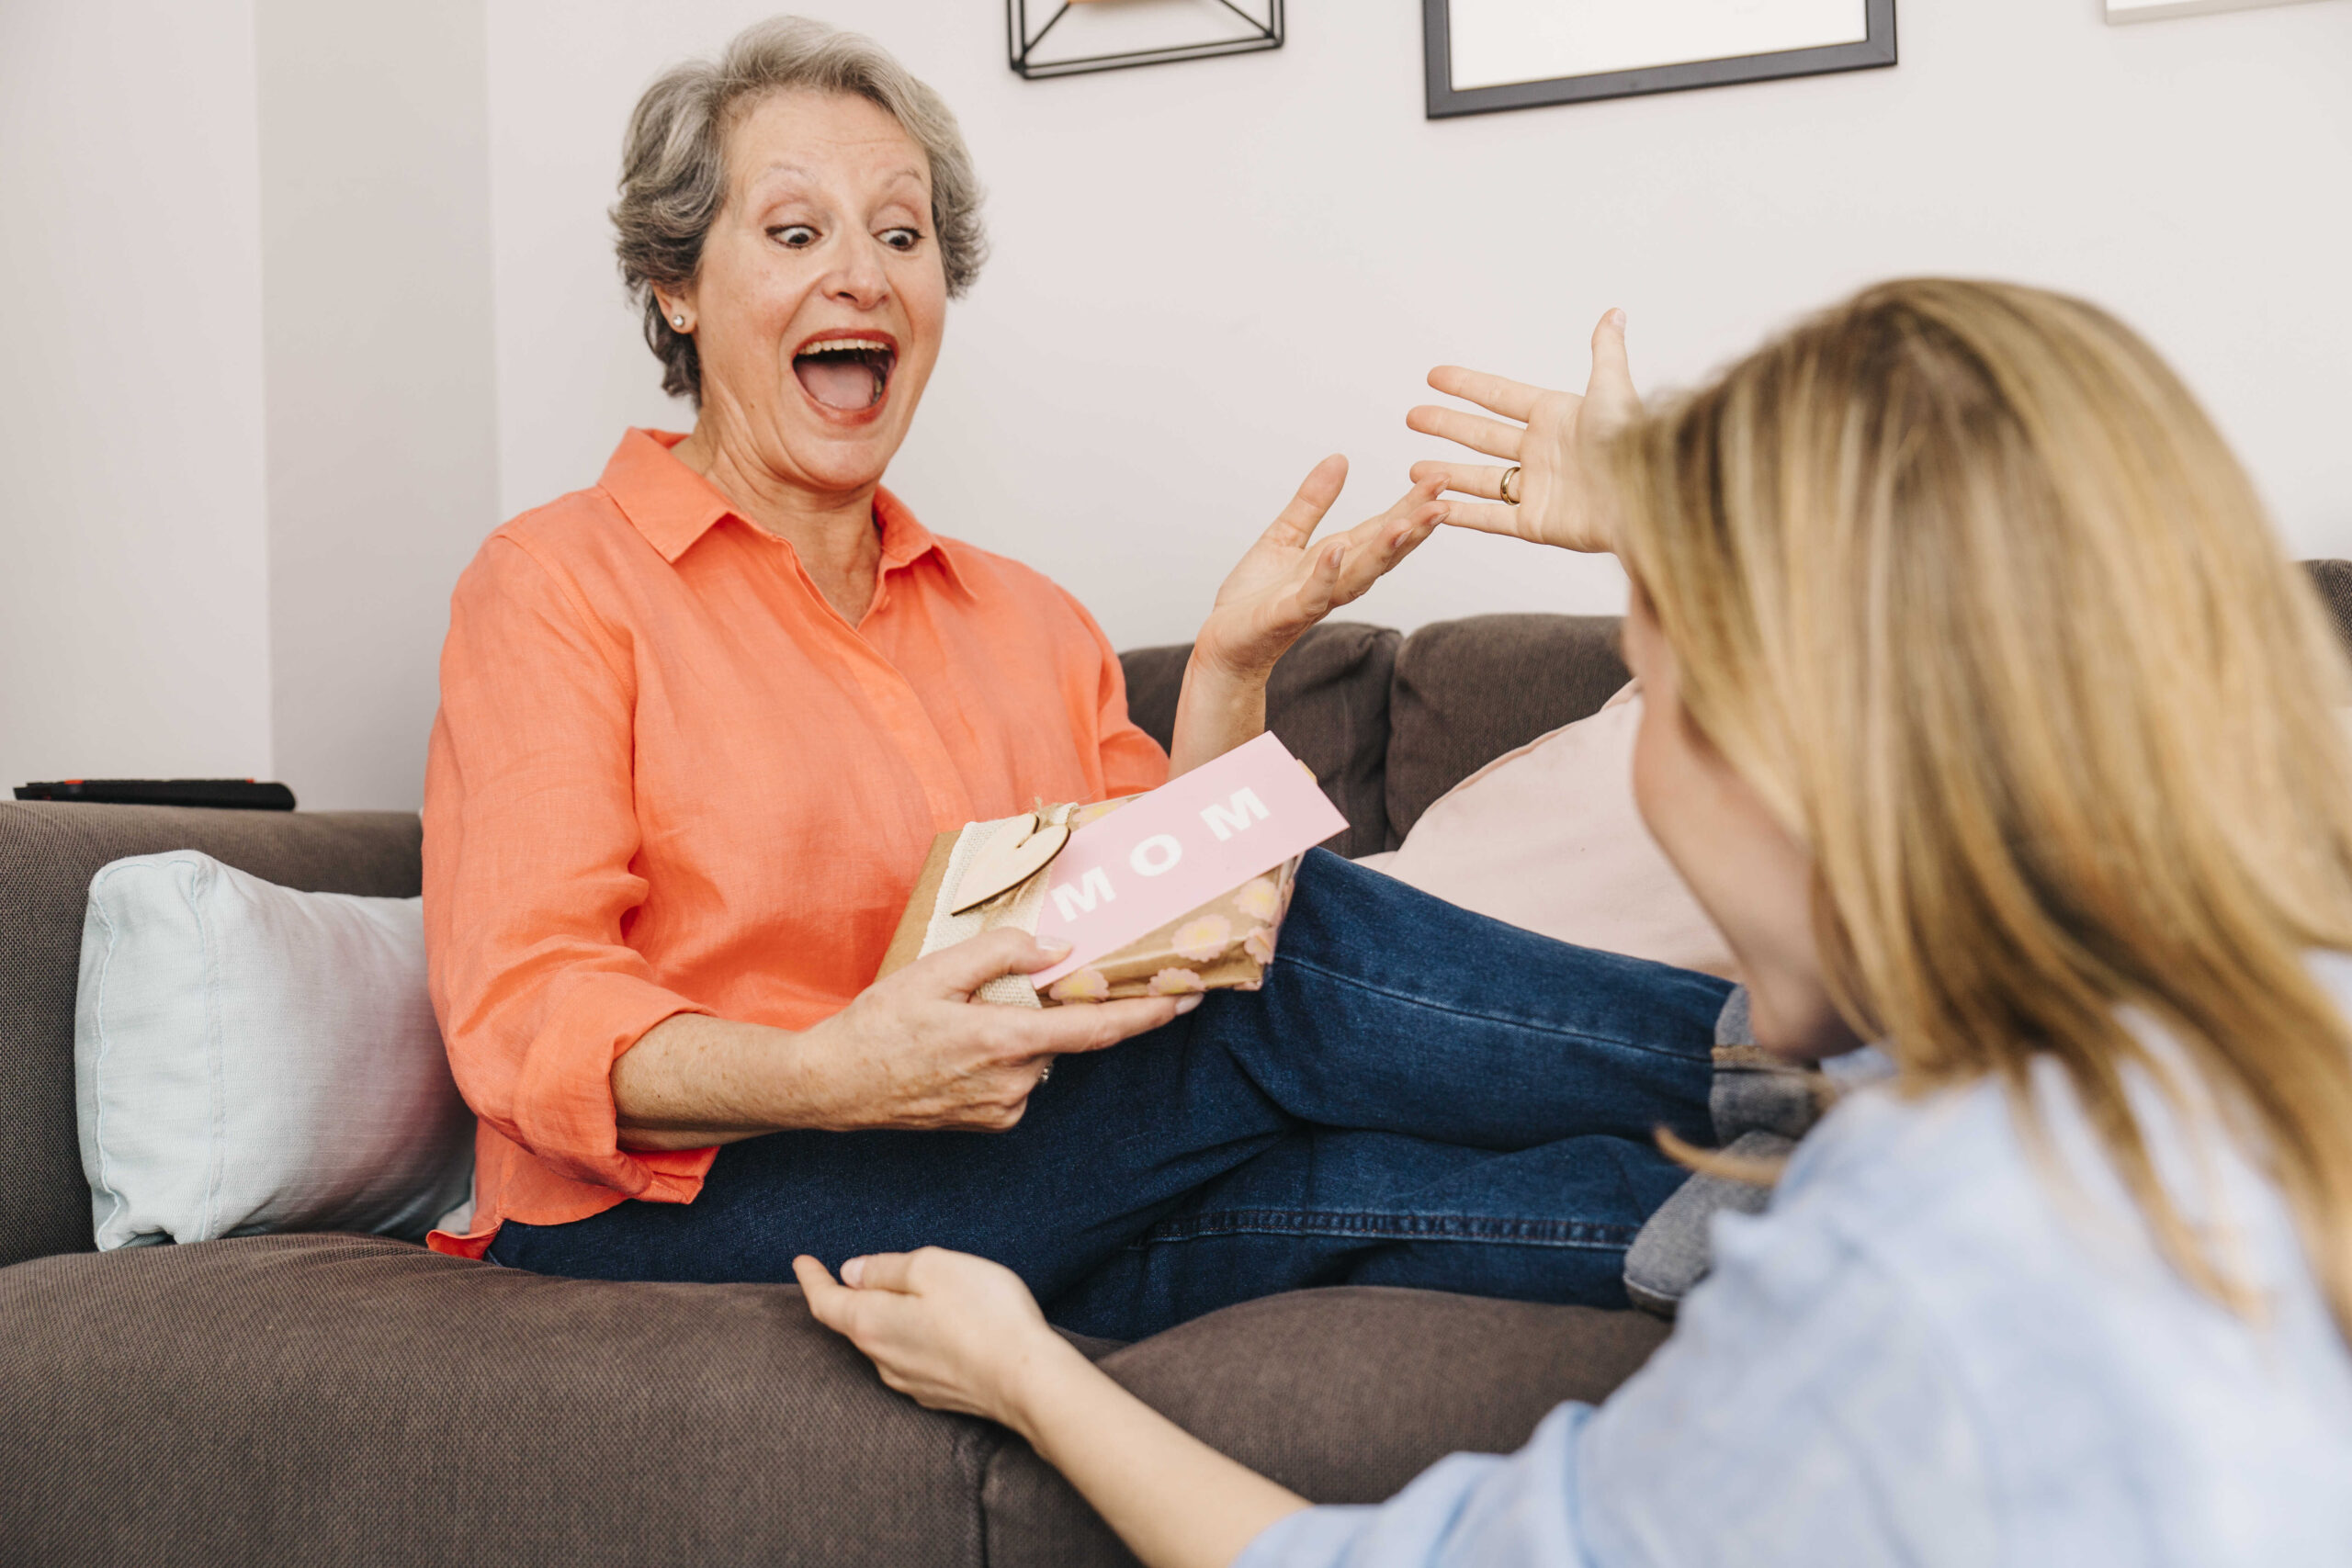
[882,797,1303,1006]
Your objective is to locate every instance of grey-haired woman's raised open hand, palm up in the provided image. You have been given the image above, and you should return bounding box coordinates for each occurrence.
[1193,456,1444,682]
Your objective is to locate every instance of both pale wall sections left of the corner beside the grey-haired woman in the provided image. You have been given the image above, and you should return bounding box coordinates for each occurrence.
[0,0,499,808]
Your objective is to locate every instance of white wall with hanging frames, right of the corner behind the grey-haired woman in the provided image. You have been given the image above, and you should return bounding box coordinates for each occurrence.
[489,0,2352,644]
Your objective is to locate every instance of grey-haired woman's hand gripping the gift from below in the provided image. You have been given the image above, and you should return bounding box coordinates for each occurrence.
[811,931,1200,1134]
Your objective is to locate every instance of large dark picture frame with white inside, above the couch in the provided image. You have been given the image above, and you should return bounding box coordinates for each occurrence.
[1420,0,1895,120]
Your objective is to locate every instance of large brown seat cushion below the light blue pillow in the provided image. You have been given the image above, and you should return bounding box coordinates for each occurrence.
[0,1236,1000,1568]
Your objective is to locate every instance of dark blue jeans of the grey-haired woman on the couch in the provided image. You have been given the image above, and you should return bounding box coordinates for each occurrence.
[489,851,1731,1340]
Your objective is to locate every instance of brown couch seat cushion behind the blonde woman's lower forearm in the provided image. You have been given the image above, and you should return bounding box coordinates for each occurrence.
[981,1286,1668,1568]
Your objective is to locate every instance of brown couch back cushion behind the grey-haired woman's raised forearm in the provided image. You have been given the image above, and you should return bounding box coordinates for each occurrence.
[1120,621,1402,856]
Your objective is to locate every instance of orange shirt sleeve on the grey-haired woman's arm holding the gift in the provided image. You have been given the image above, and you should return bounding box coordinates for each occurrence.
[425,538,710,1201]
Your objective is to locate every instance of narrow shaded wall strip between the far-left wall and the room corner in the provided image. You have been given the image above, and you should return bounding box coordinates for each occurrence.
[256,0,499,808]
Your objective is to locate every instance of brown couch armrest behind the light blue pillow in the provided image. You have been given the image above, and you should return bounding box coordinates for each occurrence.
[0,802,424,1267]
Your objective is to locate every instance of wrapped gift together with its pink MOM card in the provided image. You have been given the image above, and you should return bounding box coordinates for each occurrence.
[882,733,1348,1006]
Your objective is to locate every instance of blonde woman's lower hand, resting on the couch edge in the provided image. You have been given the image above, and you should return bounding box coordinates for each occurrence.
[793,1246,1077,1427]
